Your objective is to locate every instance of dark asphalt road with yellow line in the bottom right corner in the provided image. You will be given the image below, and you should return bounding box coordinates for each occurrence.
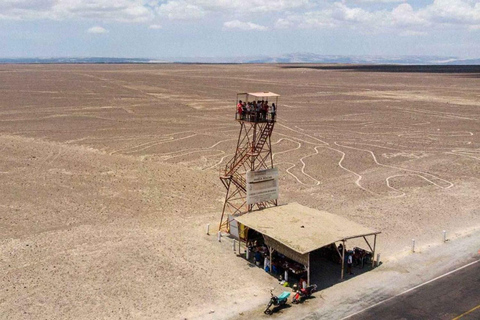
[348,262,480,320]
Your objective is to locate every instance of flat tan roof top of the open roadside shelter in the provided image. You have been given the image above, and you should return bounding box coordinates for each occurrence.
[235,202,380,254]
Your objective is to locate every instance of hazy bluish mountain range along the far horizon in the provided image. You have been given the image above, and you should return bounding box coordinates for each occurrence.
[0,53,480,65]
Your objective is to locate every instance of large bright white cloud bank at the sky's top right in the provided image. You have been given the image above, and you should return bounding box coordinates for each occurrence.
[276,0,480,36]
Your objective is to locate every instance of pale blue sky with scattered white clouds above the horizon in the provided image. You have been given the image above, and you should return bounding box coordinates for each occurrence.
[0,0,480,59]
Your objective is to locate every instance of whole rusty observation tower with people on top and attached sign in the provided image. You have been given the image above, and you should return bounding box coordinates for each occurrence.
[219,92,279,232]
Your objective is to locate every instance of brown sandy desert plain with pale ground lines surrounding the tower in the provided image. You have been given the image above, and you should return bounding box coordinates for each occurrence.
[0,65,480,319]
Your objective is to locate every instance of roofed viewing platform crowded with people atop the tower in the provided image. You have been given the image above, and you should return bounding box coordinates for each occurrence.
[235,92,279,123]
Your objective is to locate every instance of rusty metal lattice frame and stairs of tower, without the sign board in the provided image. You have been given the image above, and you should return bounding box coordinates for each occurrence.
[219,93,278,232]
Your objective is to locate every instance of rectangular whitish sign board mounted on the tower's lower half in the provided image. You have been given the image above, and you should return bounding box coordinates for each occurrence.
[247,168,278,205]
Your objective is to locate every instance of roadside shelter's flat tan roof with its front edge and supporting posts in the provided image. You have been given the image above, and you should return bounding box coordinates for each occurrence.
[231,203,380,285]
